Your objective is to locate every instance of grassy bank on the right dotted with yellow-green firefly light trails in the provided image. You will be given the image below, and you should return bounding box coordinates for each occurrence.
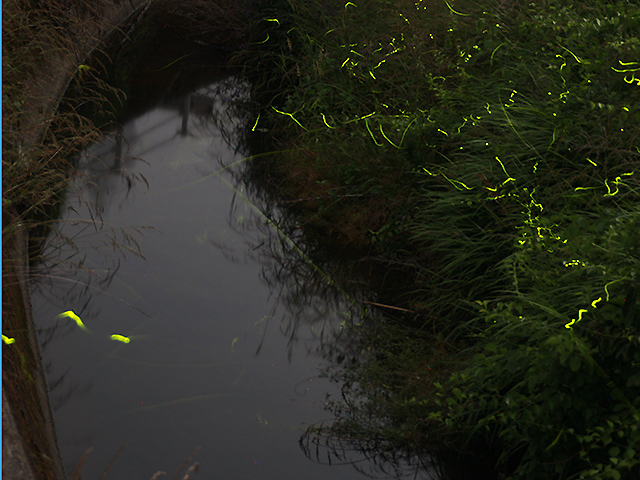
[243,0,640,479]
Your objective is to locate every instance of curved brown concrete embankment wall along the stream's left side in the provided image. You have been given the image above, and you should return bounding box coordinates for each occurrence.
[2,0,154,480]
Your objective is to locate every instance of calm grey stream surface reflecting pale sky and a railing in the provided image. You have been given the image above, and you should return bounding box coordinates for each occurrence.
[33,72,440,480]
